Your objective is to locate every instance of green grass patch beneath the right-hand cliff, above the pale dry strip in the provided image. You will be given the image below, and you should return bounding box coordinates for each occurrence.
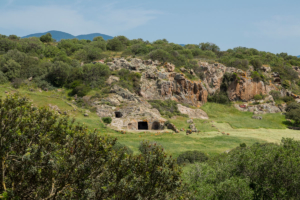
[201,103,286,129]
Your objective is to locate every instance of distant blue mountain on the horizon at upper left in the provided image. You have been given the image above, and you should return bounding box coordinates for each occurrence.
[22,31,113,41]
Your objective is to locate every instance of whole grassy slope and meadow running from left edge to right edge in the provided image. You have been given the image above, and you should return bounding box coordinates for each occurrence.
[0,85,300,157]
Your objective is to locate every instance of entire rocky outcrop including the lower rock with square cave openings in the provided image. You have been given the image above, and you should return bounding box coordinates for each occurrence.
[93,58,299,131]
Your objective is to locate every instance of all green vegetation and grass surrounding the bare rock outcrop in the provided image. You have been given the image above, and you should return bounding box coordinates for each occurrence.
[0,34,300,199]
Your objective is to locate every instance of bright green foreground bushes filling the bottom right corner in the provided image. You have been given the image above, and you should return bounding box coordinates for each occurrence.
[188,139,300,199]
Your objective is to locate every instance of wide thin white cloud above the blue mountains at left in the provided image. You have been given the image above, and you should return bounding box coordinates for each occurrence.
[0,3,160,35]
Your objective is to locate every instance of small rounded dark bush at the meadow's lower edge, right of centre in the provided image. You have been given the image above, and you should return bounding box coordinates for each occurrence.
[177,150,208,165]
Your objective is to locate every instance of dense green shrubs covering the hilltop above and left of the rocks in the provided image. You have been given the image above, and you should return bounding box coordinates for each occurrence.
[0,33,300,96]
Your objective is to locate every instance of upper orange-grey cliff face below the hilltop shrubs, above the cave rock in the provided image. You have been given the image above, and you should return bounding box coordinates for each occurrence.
[103,58,296,107]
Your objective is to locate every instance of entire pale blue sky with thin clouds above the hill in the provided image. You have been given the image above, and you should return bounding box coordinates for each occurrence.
[0,0,300,56]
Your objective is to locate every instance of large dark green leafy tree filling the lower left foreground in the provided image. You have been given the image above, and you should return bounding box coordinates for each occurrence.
[0,95,189,199]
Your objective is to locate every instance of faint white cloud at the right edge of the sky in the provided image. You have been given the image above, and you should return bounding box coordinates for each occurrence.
[246,16,300,39]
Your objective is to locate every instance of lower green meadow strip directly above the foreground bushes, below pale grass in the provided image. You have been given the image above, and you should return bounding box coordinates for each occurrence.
[105,131,264,157]
